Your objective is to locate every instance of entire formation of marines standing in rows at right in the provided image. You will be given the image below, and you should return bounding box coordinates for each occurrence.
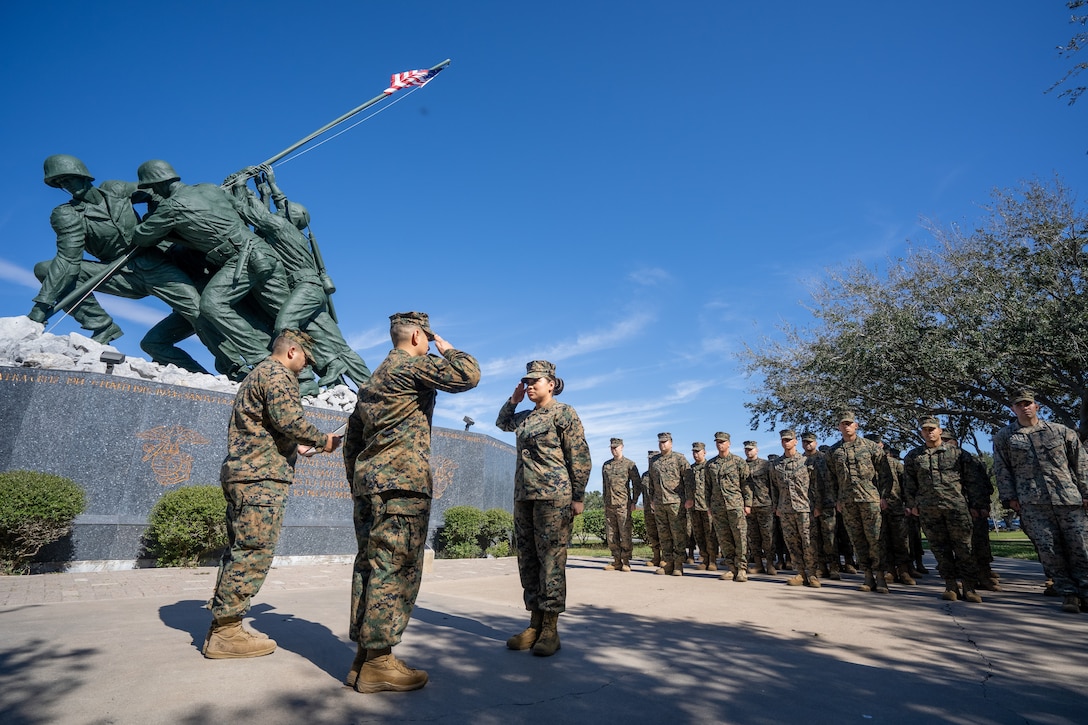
[602,400,1088,612]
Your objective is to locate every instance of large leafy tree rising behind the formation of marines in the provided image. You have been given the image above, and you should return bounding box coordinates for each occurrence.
[740,180,1088,448]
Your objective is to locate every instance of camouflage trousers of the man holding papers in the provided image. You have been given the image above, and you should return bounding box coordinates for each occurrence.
[211,481,290,620]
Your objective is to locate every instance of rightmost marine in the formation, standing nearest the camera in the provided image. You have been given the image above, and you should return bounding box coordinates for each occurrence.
[993,390,1088,612]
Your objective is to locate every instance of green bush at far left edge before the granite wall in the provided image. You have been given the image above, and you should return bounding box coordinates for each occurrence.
[0,470,86,574]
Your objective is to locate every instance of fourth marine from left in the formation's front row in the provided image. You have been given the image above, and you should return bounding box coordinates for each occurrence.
[770,428,820,587]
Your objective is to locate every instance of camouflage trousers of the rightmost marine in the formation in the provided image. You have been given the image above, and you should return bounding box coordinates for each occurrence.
[1021,503,1088,598]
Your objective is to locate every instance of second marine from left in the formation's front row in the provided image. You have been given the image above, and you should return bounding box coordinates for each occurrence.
[650,433,691,577]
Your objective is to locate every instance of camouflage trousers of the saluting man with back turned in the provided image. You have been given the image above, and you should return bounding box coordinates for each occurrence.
[348,491,431,650]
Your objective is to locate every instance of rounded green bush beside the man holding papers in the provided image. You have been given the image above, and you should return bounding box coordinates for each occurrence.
[144,486,227,566]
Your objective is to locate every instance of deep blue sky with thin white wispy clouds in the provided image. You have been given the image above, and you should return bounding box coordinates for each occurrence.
[0,0,1088,488]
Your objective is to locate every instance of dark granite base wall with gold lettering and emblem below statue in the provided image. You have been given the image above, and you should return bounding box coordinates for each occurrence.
[0,367,515,568]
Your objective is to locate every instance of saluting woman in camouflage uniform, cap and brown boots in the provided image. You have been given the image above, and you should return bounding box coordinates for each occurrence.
[495,360,593,656]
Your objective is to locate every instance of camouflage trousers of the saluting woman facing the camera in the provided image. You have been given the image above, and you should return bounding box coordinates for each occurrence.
[514,501,574,614]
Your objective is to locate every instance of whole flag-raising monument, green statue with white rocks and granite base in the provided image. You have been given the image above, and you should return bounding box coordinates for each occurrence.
[0,60,515,568]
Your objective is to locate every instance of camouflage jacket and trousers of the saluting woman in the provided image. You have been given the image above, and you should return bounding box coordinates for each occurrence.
[495,400,593,614]
